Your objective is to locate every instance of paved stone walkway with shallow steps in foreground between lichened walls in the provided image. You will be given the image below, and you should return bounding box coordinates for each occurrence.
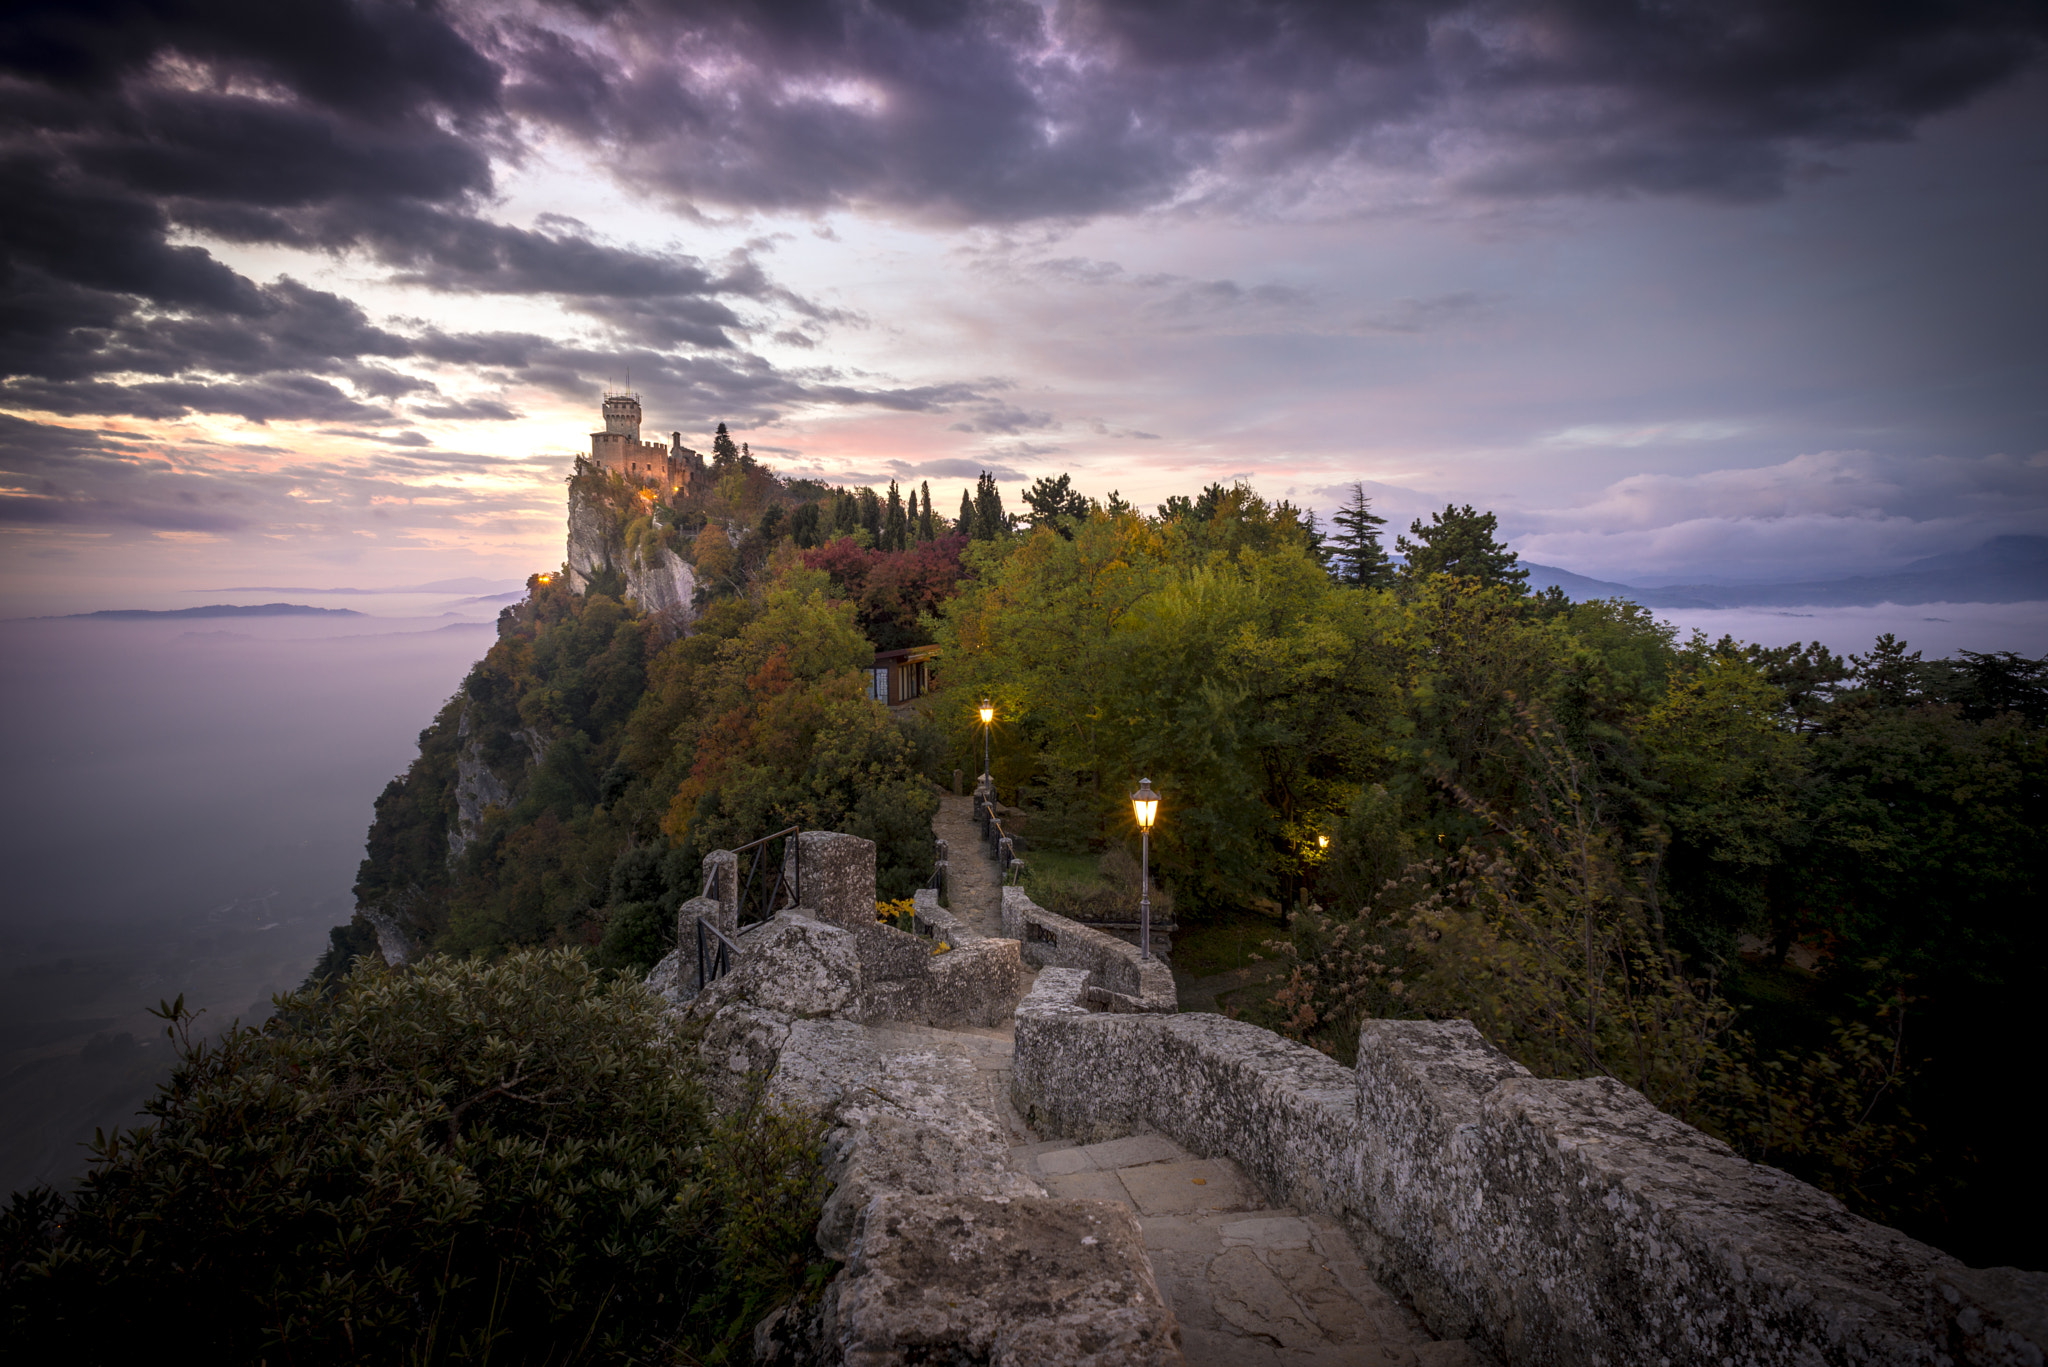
[888,1016,1487,1367]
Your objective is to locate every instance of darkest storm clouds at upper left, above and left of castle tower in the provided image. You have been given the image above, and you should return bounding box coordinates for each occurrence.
[0,0,856,441]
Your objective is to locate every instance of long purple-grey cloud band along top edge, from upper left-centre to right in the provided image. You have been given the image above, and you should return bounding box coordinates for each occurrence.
[502,0,2048,221]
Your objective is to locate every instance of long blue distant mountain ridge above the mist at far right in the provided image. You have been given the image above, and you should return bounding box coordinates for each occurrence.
[1522,537,2048,607]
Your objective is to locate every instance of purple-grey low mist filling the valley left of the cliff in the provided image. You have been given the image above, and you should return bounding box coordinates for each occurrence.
[0,619,492,1191]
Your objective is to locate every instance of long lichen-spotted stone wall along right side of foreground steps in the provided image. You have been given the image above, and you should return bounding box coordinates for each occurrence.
[1014,969,2048,1367]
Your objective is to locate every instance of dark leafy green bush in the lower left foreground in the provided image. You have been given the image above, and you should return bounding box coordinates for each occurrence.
[0,951,821,1363]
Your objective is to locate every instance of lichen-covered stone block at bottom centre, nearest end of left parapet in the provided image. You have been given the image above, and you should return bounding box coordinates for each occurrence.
[829,1193,1182,1367]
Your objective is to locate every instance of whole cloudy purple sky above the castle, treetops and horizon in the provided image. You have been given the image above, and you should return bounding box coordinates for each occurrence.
[0,0,2048,611]
